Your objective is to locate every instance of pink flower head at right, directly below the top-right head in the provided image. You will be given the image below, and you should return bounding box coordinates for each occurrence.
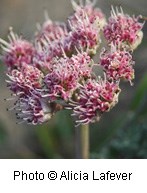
[100,45,134,82]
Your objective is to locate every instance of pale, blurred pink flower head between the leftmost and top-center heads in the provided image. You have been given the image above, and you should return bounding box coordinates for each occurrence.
[35,15,72,61]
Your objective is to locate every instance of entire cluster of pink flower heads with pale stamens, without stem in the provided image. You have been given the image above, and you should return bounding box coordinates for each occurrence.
[0,0,143,125]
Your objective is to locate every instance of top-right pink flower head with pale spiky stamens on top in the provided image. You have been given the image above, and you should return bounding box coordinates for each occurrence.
[103,8,143,50]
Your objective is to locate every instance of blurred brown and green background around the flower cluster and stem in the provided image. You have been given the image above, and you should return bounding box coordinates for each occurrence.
[0,0,147,158]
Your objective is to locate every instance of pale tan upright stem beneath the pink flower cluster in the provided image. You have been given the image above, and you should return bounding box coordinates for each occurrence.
[75,124,89,159]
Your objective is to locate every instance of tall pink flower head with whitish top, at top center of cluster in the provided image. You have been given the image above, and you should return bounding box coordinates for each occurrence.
[68,3,101,55]
